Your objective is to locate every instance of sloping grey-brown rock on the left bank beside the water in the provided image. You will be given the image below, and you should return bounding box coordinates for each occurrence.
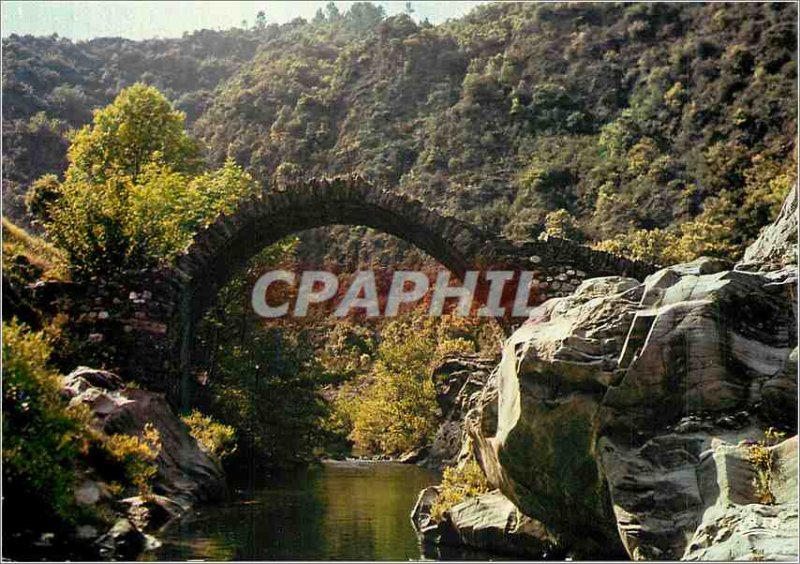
[62,367,225,559]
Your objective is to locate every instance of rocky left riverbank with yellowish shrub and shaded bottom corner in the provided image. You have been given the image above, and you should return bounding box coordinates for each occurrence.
[3,367,226,560]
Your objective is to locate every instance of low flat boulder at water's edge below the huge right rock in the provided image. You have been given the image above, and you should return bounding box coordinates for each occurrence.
[411,486,553,559]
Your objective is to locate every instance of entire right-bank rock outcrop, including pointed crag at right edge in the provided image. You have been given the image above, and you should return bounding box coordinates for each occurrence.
[413,190,798,560]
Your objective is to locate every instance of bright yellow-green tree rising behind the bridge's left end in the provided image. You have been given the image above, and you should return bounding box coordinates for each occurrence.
[39,85,257,276]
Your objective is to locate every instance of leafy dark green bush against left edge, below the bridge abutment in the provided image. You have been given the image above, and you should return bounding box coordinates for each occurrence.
[3,322,90,534]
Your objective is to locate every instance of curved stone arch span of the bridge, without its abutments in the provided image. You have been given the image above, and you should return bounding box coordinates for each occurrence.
[173,176,496,328]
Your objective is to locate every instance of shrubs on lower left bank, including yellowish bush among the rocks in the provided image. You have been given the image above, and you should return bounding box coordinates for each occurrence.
[3,320,161,559]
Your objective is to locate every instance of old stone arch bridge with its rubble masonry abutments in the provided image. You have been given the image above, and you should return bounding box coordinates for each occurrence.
[47,176,655,400]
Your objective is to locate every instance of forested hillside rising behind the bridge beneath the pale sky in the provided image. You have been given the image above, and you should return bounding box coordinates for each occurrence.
[3,4,796,262]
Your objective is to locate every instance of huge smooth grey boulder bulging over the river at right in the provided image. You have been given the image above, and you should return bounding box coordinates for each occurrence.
[467,259,797,559]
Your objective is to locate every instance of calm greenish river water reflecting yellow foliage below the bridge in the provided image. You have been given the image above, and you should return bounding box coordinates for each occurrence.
[146,462,456,560]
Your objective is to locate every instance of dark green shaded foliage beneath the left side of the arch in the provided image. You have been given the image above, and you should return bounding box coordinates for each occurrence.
[192,239,336,471]
